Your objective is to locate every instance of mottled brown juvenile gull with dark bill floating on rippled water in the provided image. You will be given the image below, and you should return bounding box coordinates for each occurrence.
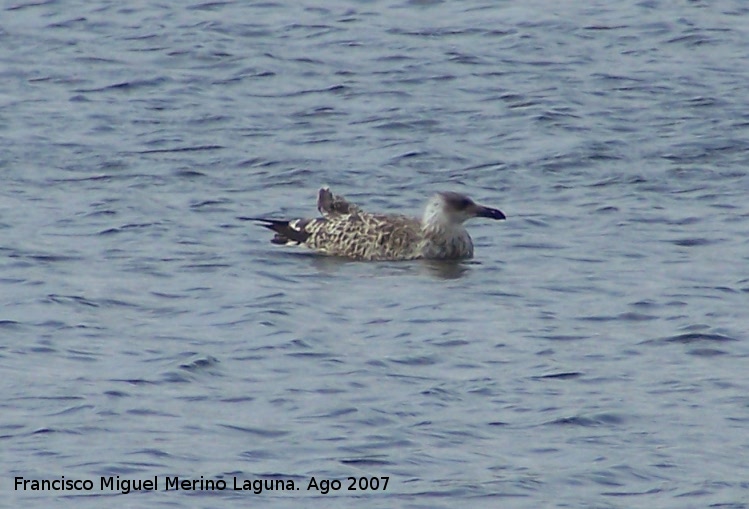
[246,188,505,260]
